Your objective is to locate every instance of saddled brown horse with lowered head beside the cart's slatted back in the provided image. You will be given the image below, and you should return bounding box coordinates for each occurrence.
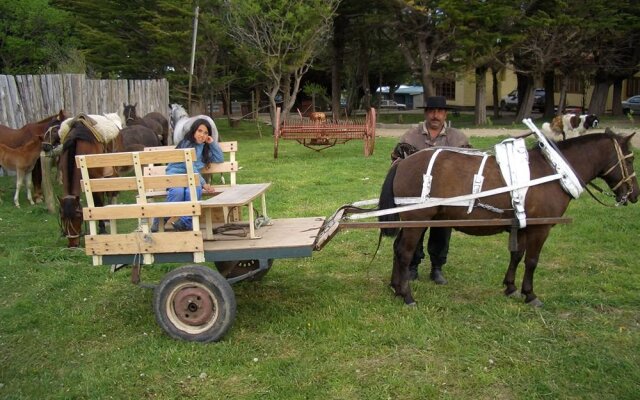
[58,121,124,247]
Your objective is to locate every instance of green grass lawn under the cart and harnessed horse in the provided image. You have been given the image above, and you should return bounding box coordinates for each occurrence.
[0,122,640,400]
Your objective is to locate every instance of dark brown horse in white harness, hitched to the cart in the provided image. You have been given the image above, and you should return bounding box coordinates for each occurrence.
[379,132,638,306]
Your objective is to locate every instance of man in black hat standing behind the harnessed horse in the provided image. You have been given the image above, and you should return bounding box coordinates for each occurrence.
[394,96,470,285]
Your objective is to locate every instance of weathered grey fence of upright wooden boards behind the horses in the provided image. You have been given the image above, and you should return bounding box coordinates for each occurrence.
[0,74,169,128]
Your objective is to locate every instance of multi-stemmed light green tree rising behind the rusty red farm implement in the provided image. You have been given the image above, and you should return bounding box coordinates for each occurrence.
[225,0,339,123]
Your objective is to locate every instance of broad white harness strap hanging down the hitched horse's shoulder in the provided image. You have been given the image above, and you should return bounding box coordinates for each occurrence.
[495,139,530,228]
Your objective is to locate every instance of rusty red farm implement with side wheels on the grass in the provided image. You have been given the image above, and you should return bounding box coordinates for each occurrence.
[273,108,376,158]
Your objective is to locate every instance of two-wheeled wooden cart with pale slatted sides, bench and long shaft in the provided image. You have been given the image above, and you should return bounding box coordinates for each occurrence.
[76,145,570,342]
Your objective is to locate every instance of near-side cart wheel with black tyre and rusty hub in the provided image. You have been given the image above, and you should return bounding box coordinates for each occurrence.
[153,265,236,342]
